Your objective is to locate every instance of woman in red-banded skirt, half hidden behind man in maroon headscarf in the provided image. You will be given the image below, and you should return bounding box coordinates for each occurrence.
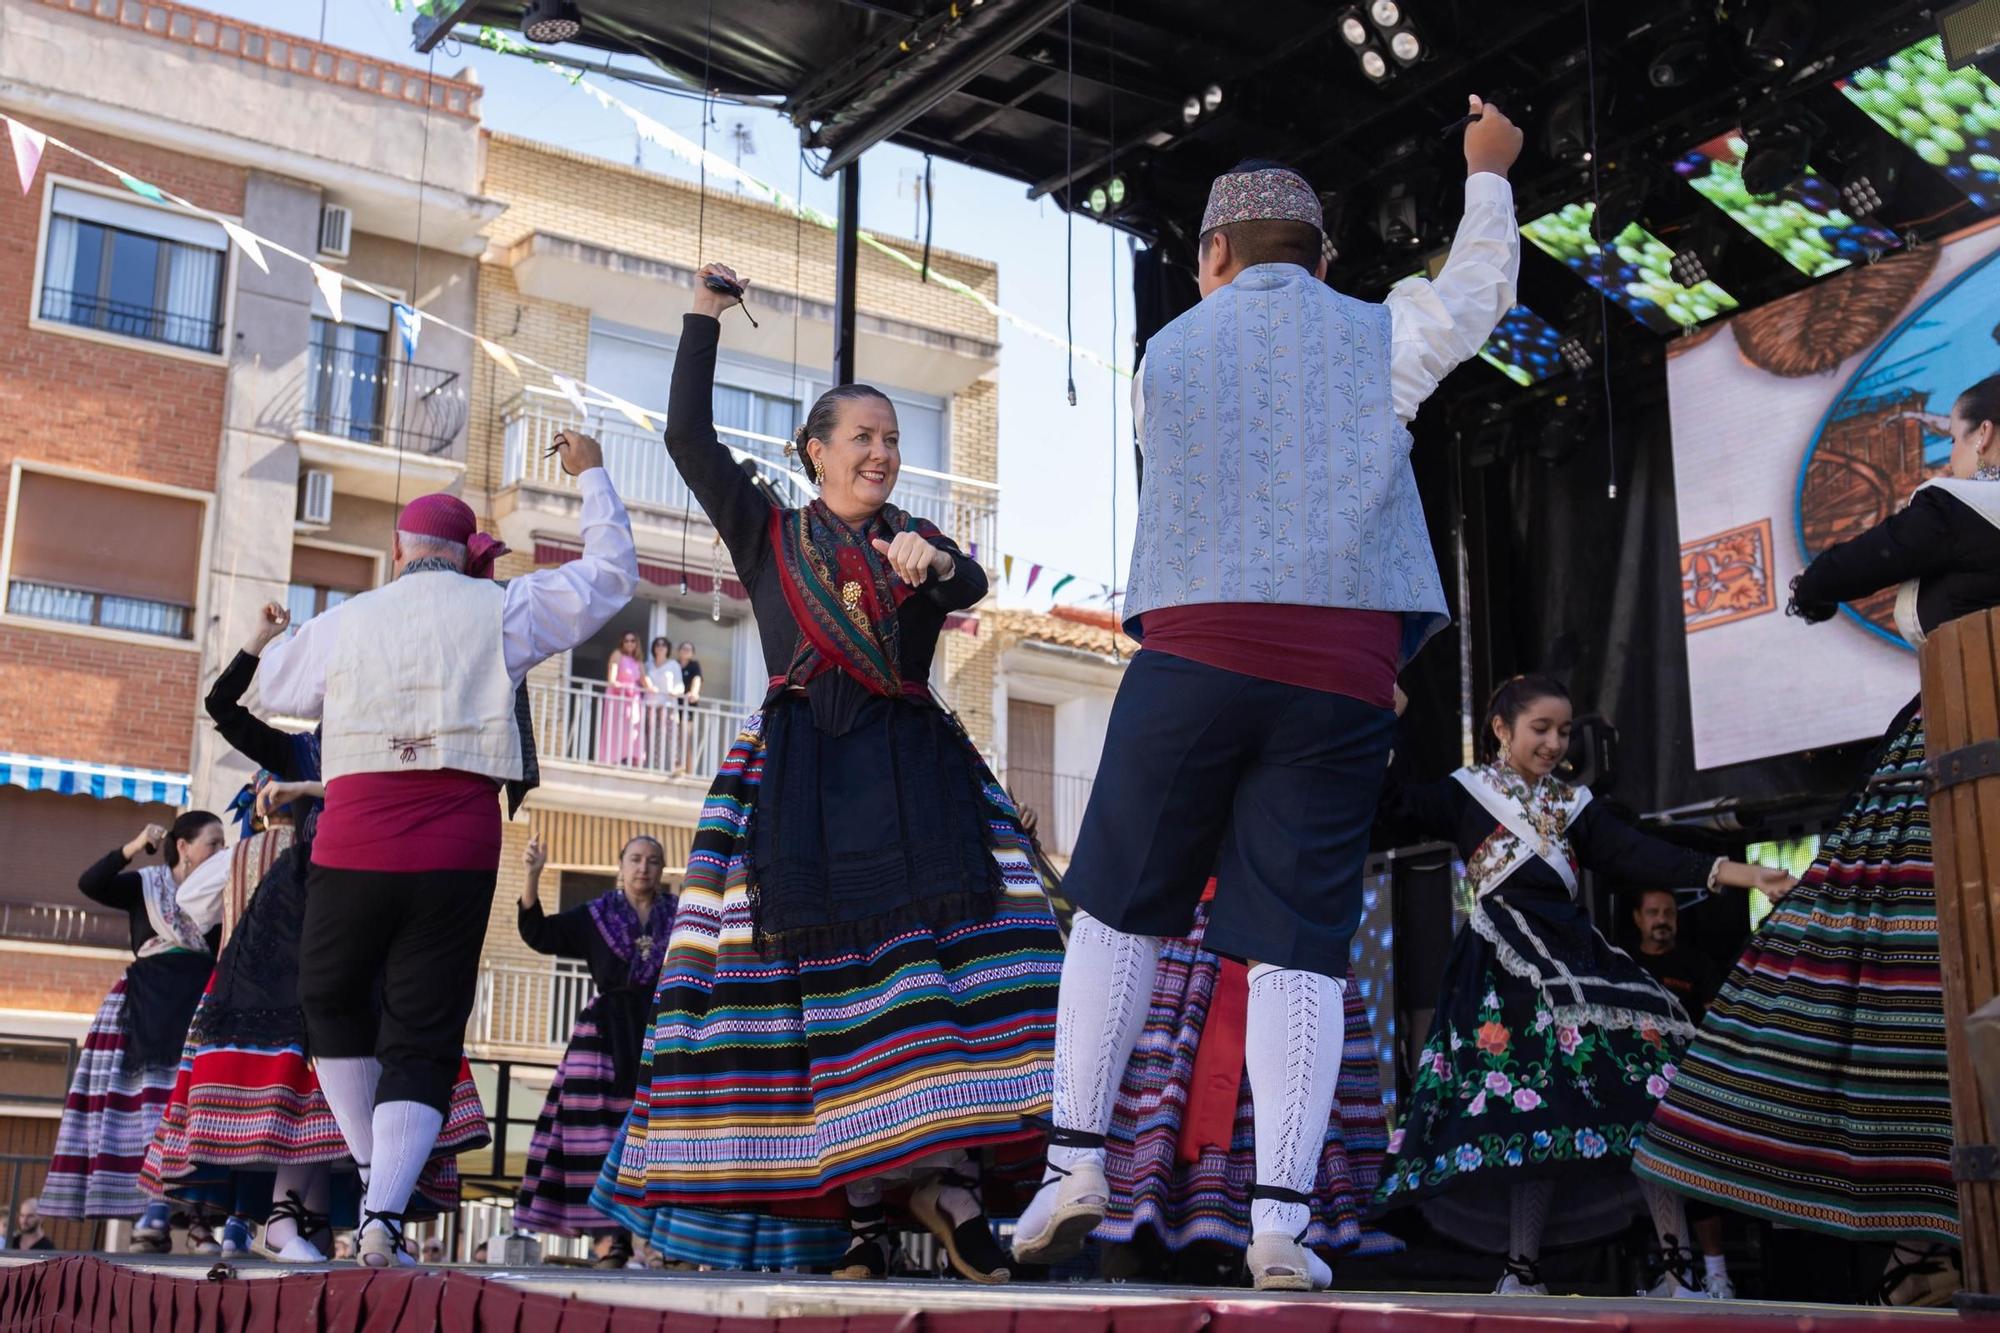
[142,602,488,1263]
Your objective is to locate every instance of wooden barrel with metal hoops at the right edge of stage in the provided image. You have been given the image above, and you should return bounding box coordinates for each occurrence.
[1920,610,2000,1295]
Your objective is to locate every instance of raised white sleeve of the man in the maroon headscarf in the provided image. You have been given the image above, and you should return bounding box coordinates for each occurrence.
[500,468,638,685]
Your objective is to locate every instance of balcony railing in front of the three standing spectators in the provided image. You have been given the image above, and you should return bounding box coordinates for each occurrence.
[528,681,750,783]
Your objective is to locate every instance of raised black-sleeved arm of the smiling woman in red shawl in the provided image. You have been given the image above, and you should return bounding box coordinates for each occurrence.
[666,274,770,580]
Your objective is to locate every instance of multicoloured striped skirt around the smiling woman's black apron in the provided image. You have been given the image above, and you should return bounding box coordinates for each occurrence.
[592,717,1062,1233]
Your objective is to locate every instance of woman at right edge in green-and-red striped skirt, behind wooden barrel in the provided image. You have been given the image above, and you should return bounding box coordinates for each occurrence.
[1634,376,2000,1305]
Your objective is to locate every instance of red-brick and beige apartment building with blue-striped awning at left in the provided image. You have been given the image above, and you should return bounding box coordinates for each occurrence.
[0,0,498,1239]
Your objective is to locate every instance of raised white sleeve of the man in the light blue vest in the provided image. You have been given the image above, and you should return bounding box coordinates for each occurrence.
[1382,172,1520,420]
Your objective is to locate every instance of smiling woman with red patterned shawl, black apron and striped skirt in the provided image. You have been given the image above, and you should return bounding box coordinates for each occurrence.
[592,264,1062,1283]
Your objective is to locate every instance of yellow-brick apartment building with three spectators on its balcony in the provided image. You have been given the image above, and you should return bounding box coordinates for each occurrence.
[466,134,1000,1120]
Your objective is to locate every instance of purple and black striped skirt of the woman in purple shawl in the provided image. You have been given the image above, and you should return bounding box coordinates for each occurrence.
[514,999,632,1235]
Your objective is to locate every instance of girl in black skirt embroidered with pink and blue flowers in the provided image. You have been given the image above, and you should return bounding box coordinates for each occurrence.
[1376,677,1792,1295]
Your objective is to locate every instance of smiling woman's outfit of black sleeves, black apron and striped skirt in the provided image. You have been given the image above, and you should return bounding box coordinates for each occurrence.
[592,314,1062,1224]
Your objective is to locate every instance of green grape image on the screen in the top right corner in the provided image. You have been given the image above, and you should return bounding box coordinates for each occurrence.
[1840,36,2000,212]
